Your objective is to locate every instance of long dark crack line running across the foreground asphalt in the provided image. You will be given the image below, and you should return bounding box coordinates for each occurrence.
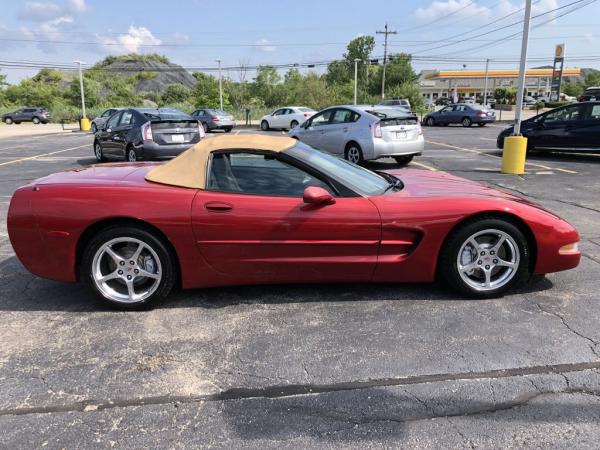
[0,361,600,416]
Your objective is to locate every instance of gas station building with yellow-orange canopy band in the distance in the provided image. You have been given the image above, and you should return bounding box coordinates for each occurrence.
[419,67,582,101]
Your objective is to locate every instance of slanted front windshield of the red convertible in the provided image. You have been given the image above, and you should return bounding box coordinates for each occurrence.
[286,142,390,196]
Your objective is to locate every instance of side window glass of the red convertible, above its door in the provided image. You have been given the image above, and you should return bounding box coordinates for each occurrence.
[207,152,334,198]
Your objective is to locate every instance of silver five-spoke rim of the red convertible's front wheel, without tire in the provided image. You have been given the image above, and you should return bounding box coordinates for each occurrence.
[456,229,520,291]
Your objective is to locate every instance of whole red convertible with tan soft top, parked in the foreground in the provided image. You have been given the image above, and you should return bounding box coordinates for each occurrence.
[8,135,580,309]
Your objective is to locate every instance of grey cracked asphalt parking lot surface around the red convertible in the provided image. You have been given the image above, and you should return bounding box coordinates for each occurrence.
[0,126,600,448]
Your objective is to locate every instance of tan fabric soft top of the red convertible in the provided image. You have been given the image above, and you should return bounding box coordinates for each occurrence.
[145,134,298,189]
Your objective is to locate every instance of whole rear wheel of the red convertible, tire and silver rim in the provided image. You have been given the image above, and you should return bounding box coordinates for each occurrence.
[80,226,176,309]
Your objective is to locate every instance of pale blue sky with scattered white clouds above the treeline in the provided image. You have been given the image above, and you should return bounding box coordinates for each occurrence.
[0,0,600,82]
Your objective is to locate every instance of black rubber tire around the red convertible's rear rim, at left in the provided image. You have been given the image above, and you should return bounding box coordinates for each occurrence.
[79,225,177,310]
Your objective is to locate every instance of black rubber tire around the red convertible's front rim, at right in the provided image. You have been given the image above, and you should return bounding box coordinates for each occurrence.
[438,216,530,298]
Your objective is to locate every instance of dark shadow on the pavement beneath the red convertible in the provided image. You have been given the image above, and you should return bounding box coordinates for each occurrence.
[0,256,553,311]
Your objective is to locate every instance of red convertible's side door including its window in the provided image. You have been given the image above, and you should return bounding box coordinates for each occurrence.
[192,153,381,284]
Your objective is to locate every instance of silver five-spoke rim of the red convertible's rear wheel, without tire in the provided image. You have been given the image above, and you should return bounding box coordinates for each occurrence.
[92,237,162,303]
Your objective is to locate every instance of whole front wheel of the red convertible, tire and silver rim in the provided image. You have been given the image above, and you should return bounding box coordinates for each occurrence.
[439,217,530,298]
